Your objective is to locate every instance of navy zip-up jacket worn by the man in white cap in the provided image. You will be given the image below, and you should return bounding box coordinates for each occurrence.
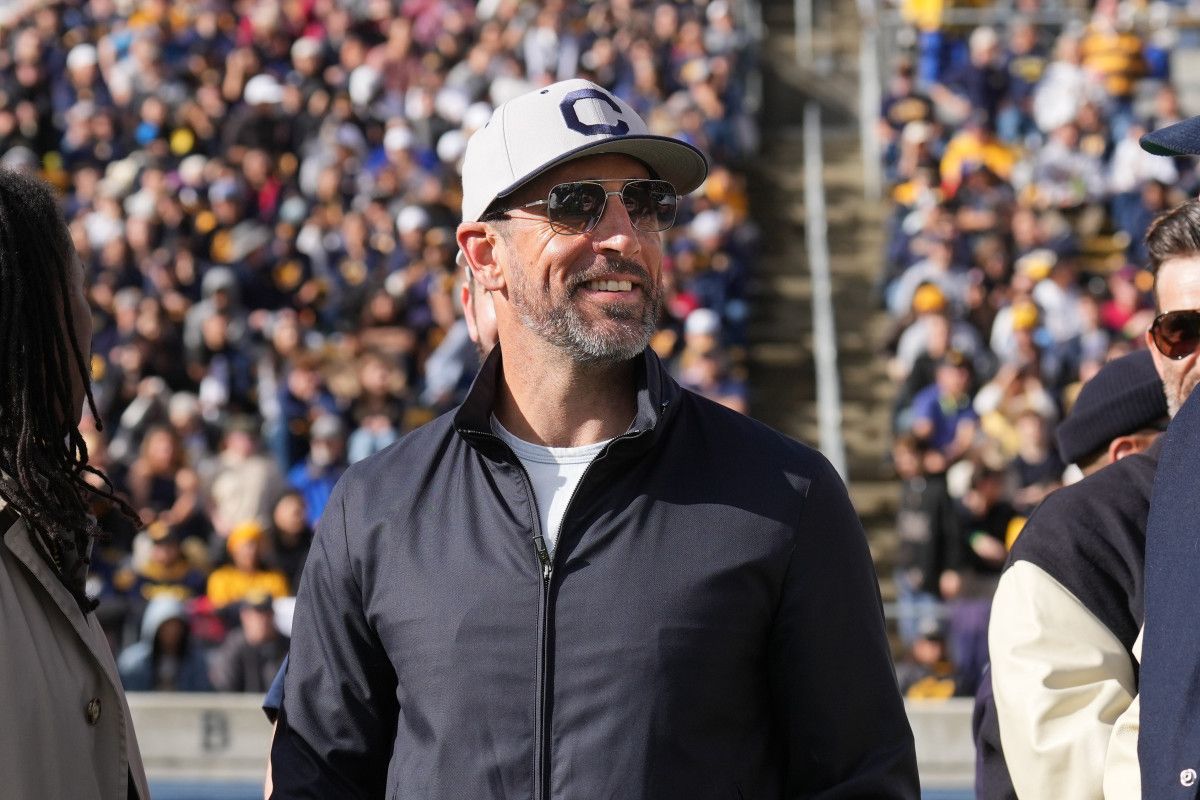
[271,348,918,800]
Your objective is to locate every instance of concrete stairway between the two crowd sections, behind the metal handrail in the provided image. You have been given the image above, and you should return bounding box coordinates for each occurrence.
[750,0,896,575]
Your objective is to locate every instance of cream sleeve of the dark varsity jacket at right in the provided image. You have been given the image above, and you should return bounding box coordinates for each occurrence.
[989,561,1136,800]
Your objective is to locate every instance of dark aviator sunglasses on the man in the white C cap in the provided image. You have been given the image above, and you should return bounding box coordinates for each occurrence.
[484,178,679,234]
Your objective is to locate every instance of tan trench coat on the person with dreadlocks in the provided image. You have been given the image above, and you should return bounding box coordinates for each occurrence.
[0,500,150,800]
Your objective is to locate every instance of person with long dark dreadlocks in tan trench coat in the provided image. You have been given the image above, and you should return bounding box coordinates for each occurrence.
[0,169,150,800]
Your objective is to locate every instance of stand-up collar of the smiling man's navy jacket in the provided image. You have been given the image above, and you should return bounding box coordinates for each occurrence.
[454,344,682,455]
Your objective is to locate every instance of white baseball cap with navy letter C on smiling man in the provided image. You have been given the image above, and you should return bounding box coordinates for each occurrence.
[462,79,708,222]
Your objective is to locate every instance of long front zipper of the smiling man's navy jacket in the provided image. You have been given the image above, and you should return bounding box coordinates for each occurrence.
[463,431,642,800]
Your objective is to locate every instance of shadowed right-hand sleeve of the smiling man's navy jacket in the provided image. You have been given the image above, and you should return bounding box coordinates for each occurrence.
[769,463,919,800]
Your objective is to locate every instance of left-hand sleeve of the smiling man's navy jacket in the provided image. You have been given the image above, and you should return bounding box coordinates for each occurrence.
[271,480,398,800]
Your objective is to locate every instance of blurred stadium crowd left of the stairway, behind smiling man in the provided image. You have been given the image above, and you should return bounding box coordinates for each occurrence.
[0,0,756,691]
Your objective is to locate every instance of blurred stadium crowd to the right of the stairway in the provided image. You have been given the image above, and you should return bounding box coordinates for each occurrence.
[878,0,1200,697]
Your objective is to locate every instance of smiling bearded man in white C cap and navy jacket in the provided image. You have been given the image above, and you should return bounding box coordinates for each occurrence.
[272,80,918,800]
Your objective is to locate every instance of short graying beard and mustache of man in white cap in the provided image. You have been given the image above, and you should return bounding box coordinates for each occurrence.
[509,258,662,365]
